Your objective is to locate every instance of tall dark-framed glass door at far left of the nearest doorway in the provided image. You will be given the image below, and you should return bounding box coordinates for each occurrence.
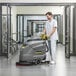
[2,4,11,58]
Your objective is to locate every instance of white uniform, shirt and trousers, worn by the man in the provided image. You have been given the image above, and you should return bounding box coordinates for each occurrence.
[45,19,58,61]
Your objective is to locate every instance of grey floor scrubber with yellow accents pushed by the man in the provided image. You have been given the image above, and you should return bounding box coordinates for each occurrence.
[16,34,49,65]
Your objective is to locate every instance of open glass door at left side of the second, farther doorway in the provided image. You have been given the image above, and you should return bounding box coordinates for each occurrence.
[16,16,24,43]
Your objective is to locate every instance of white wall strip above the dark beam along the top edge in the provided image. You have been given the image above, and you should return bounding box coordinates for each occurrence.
[0,0,76,3]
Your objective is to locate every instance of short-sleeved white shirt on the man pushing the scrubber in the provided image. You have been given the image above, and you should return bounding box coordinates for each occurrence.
[45,19,58,40]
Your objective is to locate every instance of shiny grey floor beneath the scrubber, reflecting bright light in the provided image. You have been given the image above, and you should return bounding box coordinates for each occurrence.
[0,44,76,76]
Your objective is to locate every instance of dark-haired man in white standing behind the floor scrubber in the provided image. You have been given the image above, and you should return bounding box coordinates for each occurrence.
[43,12,58,64]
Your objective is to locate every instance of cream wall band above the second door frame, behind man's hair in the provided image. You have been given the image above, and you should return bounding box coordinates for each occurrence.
[17,6,63,14]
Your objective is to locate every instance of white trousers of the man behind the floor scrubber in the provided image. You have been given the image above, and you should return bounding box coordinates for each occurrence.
[46,40,56,61]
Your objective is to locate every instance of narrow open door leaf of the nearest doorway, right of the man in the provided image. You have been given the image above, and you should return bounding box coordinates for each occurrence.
[65,6,70,58]
